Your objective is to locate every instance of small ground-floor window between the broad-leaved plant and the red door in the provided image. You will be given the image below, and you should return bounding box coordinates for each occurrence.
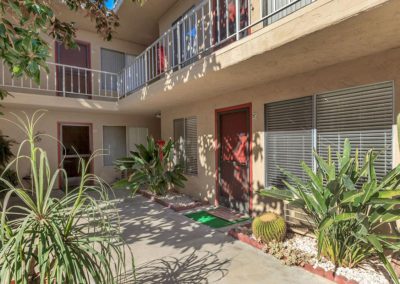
[174,117,197,175]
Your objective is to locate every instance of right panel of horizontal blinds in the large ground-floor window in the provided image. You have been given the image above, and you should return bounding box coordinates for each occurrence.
[316,82,393,177]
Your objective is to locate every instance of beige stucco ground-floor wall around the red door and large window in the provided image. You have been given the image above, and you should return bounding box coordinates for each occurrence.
[161,48,400,215]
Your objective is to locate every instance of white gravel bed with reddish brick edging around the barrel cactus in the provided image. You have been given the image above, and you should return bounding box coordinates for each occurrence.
[228,224,391,284]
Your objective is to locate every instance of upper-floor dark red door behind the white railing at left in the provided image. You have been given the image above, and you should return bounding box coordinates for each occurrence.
[56,42,92,98]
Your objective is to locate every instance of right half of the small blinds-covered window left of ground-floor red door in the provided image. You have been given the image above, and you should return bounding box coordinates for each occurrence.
[185,117,197,175]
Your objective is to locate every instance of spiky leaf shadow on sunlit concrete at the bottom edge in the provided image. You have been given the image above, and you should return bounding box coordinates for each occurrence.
[119,251,230,284]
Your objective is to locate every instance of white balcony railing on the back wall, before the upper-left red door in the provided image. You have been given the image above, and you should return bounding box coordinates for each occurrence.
[0,62,121,100]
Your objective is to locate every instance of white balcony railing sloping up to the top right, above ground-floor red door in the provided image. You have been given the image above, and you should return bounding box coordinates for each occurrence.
[120,0,316,95]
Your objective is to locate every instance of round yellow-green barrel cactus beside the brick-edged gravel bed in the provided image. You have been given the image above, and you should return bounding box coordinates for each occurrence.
[252,212,286,244]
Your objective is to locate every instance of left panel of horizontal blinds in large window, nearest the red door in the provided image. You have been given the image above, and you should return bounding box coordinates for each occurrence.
[265,96,313,187]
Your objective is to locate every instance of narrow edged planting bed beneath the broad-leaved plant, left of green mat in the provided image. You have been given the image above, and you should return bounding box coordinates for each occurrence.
[139,190,206,212]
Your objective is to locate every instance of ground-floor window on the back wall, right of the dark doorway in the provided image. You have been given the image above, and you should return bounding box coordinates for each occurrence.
[103,126,126,166]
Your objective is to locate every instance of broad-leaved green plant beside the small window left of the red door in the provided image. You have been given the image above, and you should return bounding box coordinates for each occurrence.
[114,137,186,195]
